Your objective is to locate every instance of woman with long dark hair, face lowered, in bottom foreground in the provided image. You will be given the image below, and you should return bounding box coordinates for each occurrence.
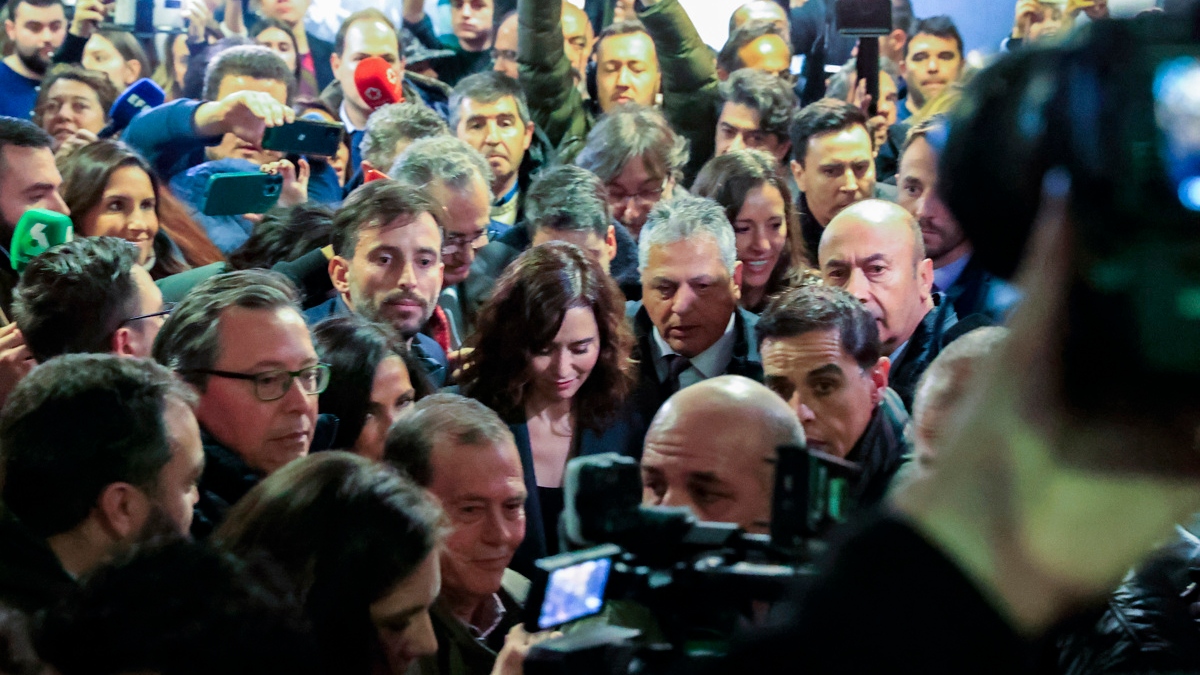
[211,452,445,675]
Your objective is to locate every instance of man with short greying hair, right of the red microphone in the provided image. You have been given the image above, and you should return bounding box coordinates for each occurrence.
[450,71,551,227]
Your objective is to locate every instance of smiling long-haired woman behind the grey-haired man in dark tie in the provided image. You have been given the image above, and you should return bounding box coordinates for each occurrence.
[691,150,811,313]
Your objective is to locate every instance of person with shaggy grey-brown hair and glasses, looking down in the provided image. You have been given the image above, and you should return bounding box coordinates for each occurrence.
[575,104,688,238]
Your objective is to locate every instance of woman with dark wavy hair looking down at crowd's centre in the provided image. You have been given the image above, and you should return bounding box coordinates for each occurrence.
[460,241,634,557]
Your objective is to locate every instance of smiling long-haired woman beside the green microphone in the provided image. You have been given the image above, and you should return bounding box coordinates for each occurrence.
[58,141,220,279]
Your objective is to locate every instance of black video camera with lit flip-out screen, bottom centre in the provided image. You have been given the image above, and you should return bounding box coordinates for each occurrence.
[524,446,860,675]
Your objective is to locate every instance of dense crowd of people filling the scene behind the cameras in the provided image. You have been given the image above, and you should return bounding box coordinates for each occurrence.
[0,0,1200,675]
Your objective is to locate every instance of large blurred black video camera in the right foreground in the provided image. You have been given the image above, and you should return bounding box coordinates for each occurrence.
[940,6,1200,429]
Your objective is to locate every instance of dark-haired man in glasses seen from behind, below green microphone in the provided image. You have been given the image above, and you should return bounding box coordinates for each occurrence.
[12,237,170,362]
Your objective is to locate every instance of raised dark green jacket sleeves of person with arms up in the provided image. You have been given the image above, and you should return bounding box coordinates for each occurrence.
[517,0,720,184]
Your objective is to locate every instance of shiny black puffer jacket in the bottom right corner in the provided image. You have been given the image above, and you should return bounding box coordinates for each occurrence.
[1058,527,1200,675]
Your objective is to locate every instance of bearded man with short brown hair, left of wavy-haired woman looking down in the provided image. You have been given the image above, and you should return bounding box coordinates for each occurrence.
[305,180,448,387]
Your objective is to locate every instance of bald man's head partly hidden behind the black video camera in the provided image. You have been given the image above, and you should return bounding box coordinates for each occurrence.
[642,375,804,533]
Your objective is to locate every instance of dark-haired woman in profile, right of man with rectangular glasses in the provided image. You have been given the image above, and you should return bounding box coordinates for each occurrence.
[312,315,433,461]
